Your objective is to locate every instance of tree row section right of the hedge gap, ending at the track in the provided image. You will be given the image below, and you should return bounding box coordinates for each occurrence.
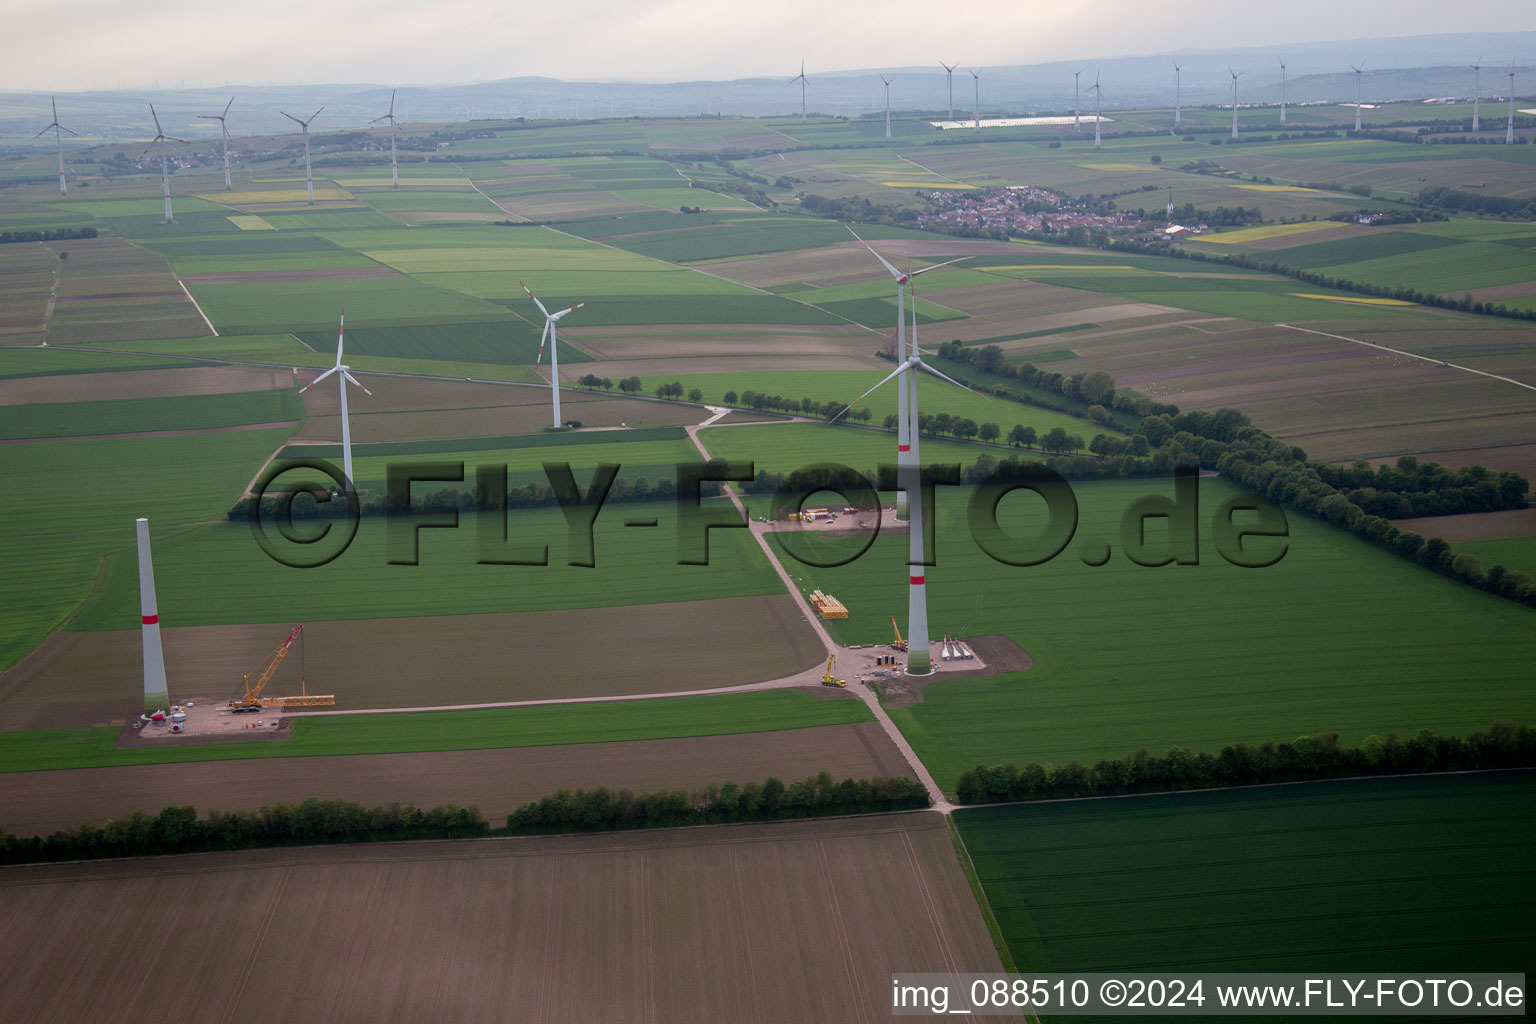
[507,772,929,835]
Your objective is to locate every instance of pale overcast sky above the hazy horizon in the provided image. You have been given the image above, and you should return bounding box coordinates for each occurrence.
[0,0,1536,91]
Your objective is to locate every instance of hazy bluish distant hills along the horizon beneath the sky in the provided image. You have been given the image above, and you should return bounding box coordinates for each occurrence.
[0,32,1536,147]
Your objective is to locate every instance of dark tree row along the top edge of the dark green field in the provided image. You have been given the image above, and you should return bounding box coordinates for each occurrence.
[955,722,1536,803]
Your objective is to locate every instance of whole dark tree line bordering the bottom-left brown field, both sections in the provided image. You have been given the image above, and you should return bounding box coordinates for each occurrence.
[0,772,929,864]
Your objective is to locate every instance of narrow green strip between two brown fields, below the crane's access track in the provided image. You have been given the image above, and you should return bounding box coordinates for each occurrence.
[0,689,874,772]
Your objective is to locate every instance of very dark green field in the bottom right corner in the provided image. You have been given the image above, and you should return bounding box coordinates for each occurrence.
[955,772,1536,973]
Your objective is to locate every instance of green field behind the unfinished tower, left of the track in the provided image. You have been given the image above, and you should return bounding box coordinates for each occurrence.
[69,497,783,629]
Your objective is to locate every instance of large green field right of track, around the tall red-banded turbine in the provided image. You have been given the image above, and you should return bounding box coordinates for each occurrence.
[774,475,1536,789]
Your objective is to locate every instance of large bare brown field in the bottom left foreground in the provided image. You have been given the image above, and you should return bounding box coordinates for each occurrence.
[0,812,1000,1024]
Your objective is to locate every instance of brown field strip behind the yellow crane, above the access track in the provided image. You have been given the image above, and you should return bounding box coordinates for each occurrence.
[0,595,825,729]
